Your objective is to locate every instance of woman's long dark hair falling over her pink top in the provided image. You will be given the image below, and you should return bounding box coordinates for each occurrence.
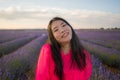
[48,17,86,80]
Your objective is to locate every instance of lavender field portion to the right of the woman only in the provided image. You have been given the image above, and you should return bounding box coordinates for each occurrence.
[76,30,120,80]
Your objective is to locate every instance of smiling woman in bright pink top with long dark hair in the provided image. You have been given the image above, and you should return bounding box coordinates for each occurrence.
[35,17,92,80]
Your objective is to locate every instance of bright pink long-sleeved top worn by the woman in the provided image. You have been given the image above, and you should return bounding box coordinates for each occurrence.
[35,43,92,80]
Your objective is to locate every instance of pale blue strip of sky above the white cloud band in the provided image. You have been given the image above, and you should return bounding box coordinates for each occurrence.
[0,0,120,13]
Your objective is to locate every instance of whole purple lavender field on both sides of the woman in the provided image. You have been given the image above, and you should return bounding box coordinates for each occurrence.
[0,30,120,80]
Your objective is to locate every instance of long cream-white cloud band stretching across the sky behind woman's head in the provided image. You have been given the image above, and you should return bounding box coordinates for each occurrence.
[0,6,120,27]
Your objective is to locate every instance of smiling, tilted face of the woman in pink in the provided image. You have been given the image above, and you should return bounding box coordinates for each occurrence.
[51,20,72,43]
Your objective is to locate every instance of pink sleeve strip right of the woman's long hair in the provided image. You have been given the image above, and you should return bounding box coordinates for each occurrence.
[85,50,92,80]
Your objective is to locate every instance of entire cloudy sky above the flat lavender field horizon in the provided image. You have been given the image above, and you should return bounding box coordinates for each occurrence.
[0,0,120,29]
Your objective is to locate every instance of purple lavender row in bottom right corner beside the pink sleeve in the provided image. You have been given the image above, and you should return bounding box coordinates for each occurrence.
[90,55,120,80]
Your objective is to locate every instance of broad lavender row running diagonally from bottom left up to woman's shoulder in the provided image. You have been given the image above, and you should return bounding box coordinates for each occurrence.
[0,35,47,80]
